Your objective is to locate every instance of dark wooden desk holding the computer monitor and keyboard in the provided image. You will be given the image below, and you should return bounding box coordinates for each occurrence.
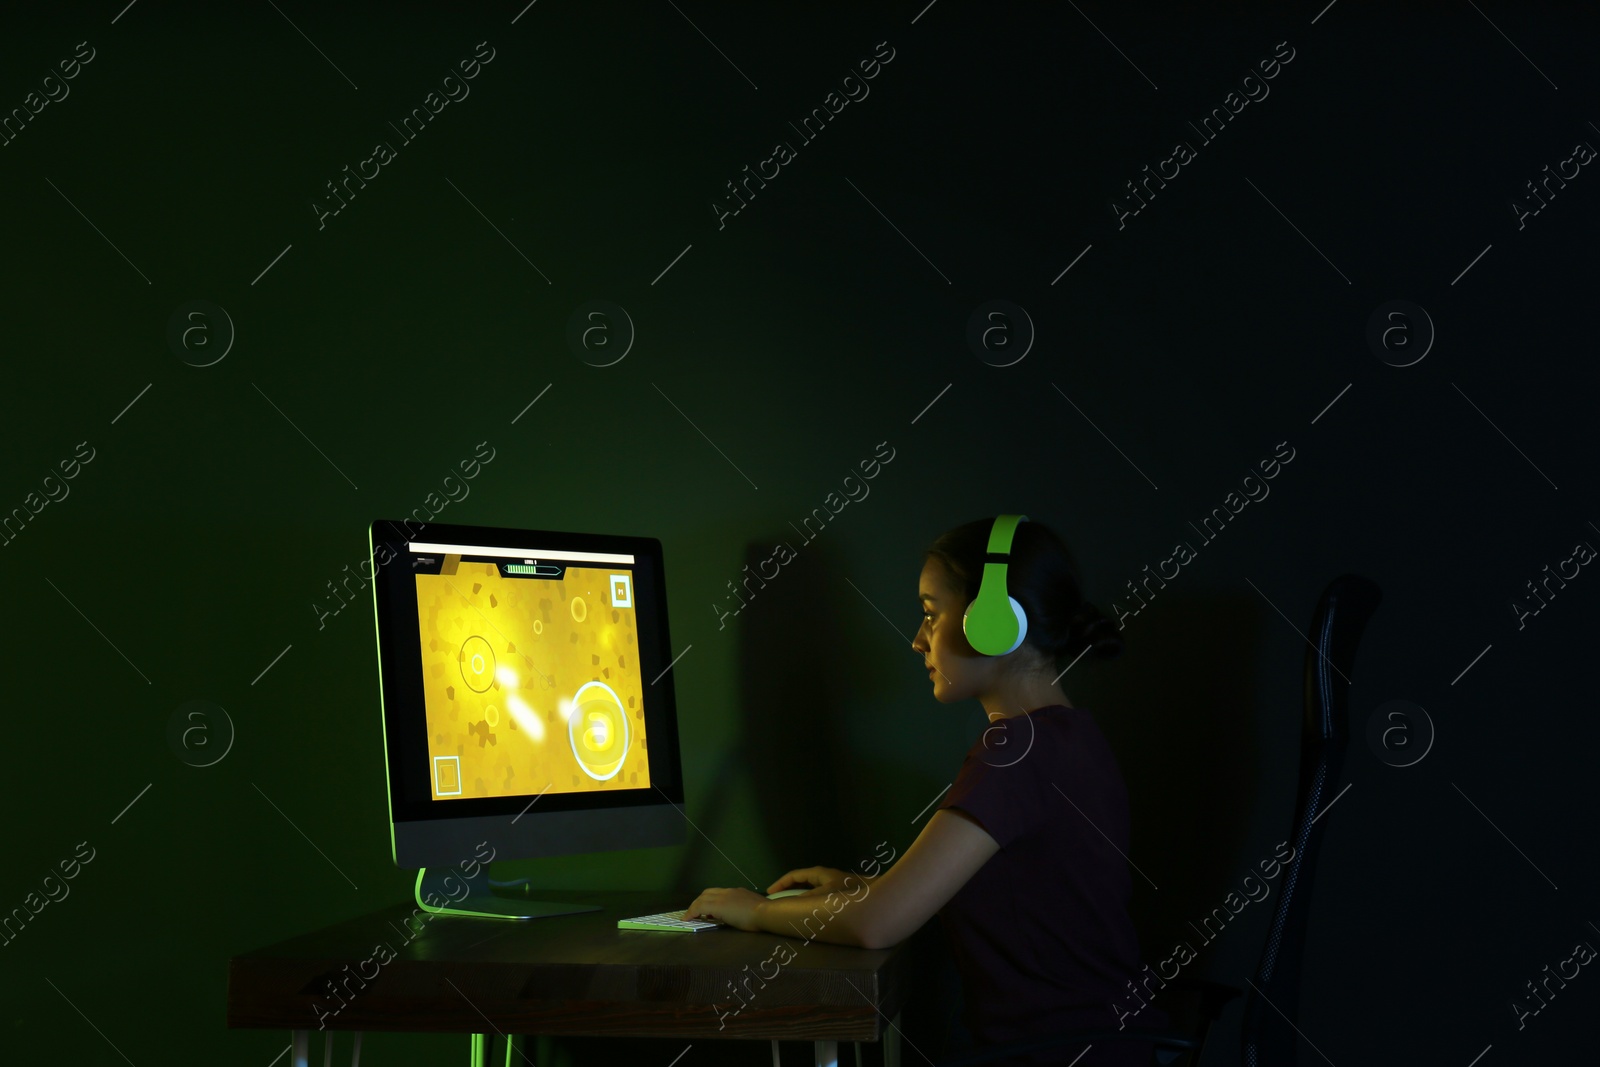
[227,889,915,1067]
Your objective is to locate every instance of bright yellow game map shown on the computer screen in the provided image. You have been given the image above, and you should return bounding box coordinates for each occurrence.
[416,555,650,800]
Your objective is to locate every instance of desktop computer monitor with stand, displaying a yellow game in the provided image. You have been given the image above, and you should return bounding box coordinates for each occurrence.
[368,520,686,918]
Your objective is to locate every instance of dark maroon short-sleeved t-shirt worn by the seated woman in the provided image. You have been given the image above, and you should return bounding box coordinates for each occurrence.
[939,704,1168,1067]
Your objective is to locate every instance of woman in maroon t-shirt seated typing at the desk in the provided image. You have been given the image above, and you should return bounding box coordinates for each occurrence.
[686,518,1166,1067]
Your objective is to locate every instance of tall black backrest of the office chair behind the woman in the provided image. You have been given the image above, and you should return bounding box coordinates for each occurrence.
[1242,574,1382,1067]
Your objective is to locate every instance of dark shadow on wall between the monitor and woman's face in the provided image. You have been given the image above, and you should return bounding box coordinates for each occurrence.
[675,533,889,893]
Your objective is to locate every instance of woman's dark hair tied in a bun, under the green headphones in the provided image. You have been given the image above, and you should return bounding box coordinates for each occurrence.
[925,518,1123,670]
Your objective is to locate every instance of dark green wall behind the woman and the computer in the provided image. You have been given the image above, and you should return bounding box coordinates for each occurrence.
[0,0,1600,1065]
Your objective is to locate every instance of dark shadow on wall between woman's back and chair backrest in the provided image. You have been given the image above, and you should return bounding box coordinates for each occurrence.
[1094,592,1267,963]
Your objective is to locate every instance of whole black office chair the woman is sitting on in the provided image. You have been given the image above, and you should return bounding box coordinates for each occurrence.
[938,574,1382,1067]
